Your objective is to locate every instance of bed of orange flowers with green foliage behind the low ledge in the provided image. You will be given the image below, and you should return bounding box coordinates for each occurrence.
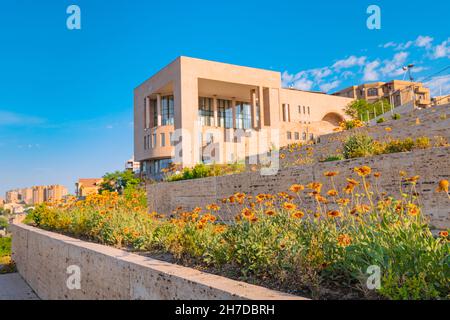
[30,171,450,299]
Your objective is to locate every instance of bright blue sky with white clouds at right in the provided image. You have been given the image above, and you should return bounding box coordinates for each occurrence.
[0,0,450,196]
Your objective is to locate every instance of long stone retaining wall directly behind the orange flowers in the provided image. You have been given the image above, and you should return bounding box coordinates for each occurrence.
[147,147,450,228]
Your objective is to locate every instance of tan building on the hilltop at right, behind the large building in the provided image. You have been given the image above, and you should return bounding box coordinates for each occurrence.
[333,80,431,108]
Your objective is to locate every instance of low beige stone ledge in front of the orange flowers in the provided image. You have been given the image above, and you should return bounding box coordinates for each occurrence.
[11,224,305,300]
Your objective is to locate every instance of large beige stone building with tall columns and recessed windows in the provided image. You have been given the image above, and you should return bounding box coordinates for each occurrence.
[134,57,353,177]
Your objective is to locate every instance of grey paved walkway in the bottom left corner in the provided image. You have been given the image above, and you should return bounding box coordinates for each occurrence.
[0,273,39,300]
